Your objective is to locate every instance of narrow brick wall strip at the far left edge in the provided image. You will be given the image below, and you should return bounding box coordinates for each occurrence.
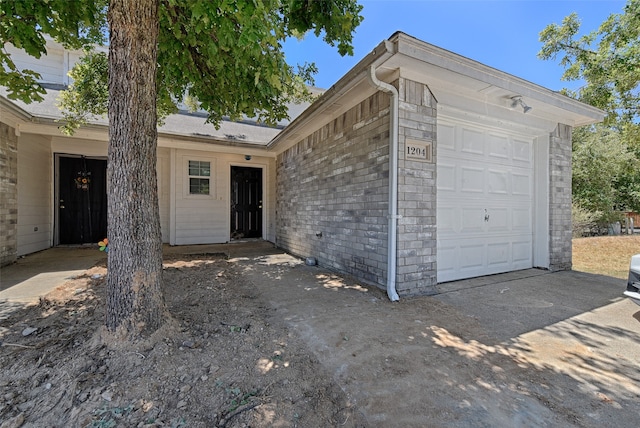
[0,123,18,266]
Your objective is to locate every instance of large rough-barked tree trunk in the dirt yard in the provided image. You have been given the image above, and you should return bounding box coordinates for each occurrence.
[106,0,166,339]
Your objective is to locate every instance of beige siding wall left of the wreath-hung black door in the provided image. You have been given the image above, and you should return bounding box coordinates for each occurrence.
[18,134,53,256]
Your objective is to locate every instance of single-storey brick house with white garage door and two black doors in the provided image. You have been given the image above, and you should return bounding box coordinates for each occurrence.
[0,32,604,300]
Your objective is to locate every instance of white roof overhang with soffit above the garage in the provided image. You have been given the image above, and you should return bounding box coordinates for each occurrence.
[269,32,606,153]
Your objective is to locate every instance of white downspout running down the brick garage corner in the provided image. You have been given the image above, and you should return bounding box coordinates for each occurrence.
[369,65,400,302]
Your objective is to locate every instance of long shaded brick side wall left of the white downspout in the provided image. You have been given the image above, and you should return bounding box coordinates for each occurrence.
[276,92,390,286]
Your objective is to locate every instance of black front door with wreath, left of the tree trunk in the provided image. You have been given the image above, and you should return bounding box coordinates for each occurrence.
[58,156,107,245]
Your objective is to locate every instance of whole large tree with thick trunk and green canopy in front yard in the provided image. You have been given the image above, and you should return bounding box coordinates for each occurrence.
[0,0,362,340]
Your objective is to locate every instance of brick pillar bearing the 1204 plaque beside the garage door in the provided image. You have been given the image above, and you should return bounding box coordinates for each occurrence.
[396,78,437,296]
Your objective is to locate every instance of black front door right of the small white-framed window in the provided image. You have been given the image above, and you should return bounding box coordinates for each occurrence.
[231,166,262,239]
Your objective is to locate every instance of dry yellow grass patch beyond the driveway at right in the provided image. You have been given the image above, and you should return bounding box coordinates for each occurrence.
[573,235,640,279]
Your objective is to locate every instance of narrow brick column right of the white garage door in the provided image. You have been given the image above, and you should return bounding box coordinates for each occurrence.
[549,124,572,270]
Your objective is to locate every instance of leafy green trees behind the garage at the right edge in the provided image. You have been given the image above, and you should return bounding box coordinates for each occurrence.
[538,0,640,231]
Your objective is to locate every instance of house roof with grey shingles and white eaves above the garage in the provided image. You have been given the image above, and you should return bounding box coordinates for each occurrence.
[0,32,605,153]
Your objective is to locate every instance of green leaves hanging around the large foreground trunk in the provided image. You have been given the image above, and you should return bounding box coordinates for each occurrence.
[0,0,362,133]
